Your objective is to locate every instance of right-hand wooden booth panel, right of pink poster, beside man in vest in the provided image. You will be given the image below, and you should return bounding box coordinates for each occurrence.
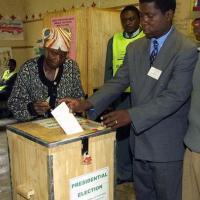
[88,8,122,95]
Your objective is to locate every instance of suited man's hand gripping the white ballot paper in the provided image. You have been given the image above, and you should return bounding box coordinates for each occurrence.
[58,98,92,113]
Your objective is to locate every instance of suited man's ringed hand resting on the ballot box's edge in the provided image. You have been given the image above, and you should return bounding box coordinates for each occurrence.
[101,110,131,129]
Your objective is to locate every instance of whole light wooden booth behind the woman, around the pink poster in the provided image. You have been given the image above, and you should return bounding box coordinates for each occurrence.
[44,8,122,95]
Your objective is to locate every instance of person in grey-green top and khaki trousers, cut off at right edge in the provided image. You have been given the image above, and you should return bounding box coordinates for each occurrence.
[183,15,200,200]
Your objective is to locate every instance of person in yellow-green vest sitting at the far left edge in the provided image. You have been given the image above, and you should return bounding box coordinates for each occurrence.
[0,59,17,101]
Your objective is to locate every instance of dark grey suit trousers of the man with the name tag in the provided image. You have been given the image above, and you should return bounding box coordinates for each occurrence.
[133,158,183,200]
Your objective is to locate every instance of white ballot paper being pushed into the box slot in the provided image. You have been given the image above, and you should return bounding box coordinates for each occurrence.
[51,102,83,135]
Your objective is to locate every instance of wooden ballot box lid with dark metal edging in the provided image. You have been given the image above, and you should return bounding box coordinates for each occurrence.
[7,117,111,147]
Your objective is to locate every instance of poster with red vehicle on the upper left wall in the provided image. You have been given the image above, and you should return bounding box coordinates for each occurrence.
[0,18,24,40]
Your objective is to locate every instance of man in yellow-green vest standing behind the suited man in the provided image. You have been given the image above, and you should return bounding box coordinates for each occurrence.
[104,5,144,183]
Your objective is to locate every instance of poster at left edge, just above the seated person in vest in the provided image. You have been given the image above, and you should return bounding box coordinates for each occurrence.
[0,47,12,74]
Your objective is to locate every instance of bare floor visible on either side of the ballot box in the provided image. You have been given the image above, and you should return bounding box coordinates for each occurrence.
[0,123,136,200]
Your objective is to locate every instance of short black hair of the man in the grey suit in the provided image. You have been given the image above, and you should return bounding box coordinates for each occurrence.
[139,0,176,13]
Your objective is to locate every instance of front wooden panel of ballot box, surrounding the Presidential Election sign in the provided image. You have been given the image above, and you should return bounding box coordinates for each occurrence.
[51,133,115,200]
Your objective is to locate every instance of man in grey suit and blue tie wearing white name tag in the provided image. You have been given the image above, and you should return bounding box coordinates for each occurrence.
[62,0,197,200]
